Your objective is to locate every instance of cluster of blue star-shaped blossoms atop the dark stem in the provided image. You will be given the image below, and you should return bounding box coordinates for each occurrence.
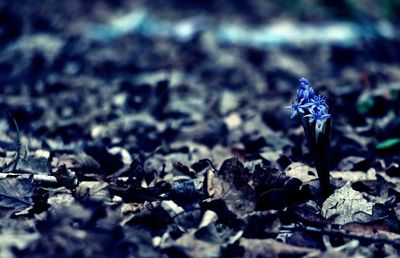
[286,78,331,129]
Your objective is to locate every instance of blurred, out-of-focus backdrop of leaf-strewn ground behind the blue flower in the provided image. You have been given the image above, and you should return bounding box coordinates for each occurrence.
[0,0,400,166]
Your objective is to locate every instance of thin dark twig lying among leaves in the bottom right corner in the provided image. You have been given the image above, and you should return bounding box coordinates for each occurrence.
[280,225,400,247]
